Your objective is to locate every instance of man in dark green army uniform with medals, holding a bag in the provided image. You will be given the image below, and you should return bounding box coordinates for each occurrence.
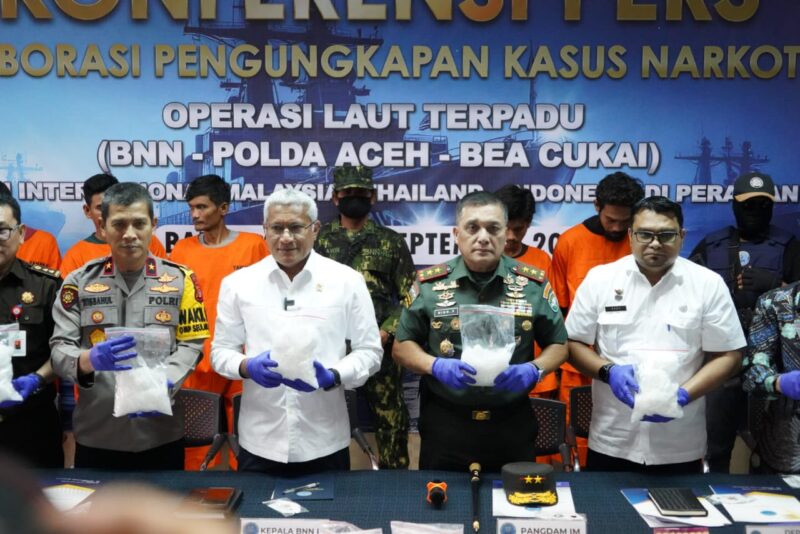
[394,191,567,472]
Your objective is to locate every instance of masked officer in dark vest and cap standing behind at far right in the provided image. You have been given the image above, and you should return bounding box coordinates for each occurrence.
[689,172,800,473]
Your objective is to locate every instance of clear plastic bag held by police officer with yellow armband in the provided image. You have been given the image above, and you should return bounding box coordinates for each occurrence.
[106,326,172,417]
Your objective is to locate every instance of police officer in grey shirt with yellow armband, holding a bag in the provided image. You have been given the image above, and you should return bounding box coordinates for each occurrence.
[50,183,208,469]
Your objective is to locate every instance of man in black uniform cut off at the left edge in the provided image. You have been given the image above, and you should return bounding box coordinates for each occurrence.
[0,195,64,468]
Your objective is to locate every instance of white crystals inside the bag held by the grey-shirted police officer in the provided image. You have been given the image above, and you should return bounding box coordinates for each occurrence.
[114,367,172,417]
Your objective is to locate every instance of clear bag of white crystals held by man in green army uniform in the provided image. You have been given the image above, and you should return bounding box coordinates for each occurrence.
[459,304,515,387]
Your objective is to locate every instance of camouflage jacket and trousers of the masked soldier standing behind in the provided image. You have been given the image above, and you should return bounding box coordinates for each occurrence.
[314,220,416,469]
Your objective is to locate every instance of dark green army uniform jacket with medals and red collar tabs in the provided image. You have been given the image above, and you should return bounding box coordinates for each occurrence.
[396,256,567,406]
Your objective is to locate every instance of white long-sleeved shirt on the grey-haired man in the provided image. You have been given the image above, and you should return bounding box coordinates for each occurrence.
[211,251,383,463]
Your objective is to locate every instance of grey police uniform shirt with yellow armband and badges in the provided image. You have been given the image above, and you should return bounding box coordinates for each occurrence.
[50,256,209,452]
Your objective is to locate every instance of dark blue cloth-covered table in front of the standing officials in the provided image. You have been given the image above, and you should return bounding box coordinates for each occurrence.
[39,469,800,534]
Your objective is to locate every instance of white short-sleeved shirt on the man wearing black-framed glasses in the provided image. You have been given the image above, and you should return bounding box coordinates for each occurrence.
[566,255,746,465]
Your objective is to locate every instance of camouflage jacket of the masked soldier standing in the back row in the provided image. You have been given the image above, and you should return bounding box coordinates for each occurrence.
[314,220,416,334]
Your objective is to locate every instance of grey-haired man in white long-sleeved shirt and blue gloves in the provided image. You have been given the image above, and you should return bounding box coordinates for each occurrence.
[211,189,383,476]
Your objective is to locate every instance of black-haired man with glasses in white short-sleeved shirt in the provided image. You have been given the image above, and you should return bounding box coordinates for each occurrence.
[566,197,746,473]
